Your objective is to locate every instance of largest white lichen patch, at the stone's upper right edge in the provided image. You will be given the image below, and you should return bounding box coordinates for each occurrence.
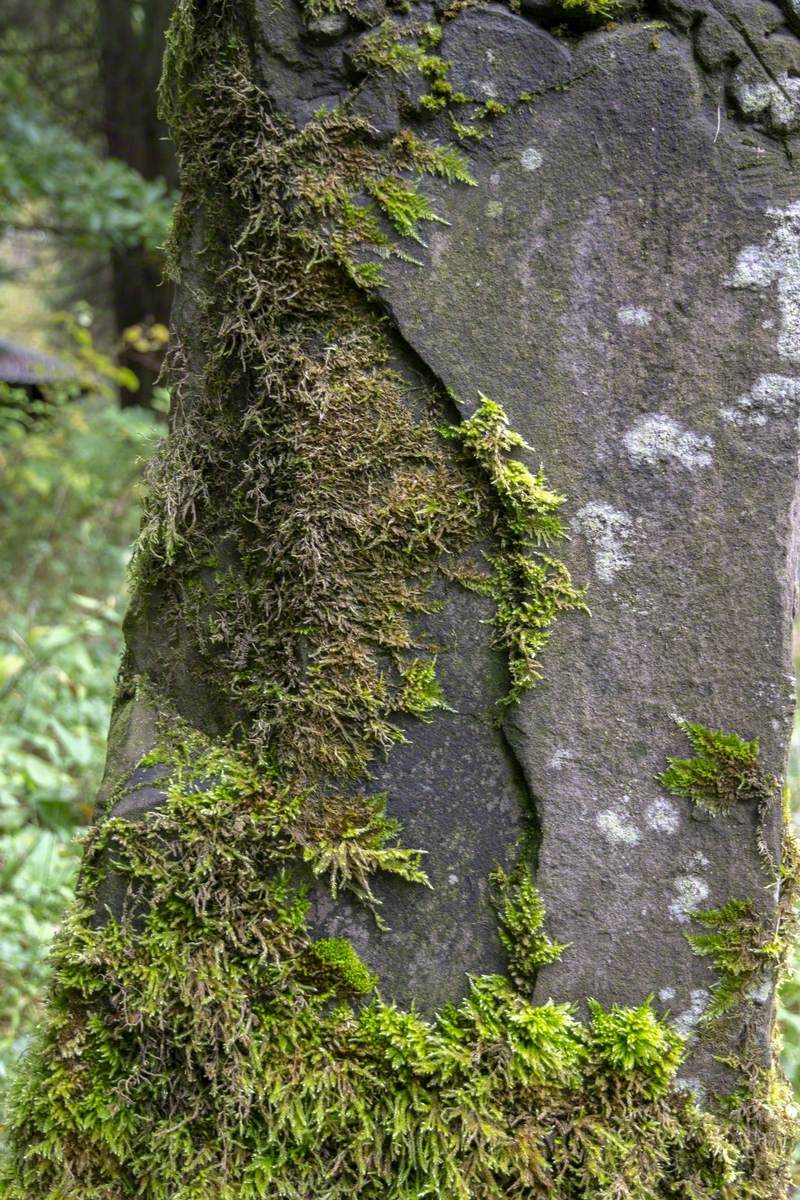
[724,200,800,362]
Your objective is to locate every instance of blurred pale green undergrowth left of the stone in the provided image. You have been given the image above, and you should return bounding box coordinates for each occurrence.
[0,367,160,1097]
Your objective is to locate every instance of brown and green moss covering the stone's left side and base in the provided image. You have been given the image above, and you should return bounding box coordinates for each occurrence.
[0,0,788,1200]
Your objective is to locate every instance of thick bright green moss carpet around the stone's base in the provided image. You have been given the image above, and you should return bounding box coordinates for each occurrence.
[4,725,768,1200]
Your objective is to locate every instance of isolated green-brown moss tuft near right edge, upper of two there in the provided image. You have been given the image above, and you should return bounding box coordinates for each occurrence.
[660,720,777,816]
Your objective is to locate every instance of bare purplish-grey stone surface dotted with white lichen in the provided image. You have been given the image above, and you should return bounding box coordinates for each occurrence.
[175,4,800,1089]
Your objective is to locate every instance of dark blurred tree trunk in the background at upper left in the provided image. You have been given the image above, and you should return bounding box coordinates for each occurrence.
[97,0,176,408]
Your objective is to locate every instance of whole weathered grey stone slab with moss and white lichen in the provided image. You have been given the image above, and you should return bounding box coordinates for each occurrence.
[6,0,800,1200]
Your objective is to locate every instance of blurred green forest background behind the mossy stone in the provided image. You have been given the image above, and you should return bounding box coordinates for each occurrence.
[0,0,800,1171]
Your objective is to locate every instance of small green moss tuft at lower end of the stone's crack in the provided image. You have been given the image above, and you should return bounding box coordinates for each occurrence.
[491,863,569,991]
